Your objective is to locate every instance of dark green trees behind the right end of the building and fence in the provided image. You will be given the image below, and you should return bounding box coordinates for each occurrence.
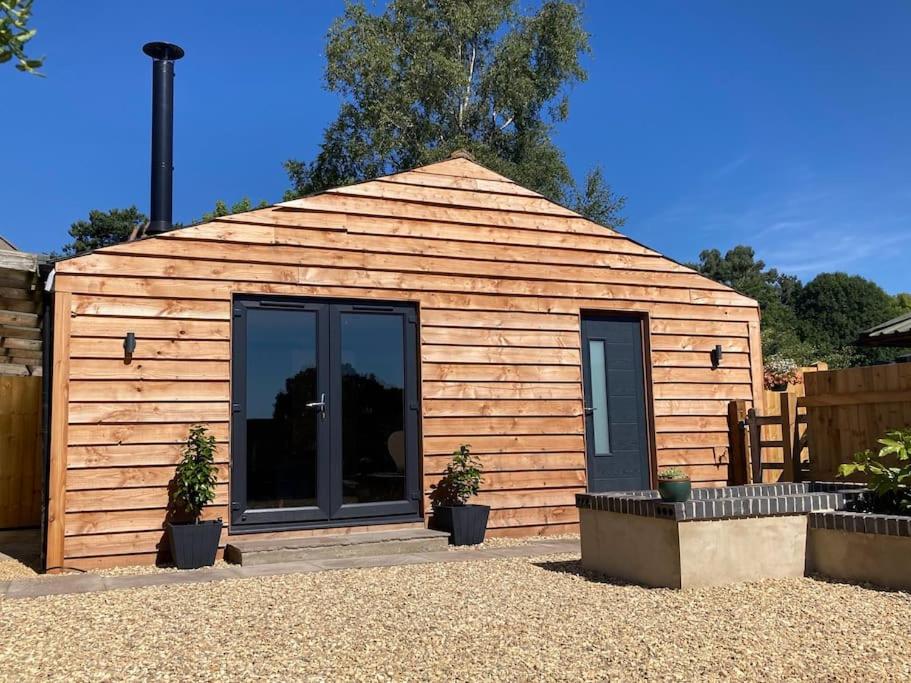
[691,245,907,367]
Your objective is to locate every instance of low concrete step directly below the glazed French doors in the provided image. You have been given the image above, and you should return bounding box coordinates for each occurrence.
[225,529,449,566]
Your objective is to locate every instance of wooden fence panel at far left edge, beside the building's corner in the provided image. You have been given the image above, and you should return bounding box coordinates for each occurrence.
[0,376,41,529]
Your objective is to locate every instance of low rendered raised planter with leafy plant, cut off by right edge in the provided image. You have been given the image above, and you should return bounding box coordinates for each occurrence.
[807,511,911,590]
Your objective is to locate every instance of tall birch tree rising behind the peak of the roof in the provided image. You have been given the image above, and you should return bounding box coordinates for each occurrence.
[285,0,624,226]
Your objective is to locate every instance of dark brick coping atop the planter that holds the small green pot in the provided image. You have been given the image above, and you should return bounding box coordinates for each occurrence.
[576,482,868,522]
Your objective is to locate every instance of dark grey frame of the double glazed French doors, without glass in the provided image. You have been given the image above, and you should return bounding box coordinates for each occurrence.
[228,292,423,535]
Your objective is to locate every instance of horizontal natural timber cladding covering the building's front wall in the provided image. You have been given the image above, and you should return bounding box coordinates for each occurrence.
[56,160,760,567]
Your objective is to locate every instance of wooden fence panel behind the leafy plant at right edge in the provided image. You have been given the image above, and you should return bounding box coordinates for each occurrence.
[798,363,911,481]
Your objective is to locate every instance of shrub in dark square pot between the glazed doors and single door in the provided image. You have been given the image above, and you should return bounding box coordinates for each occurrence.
[430,444,490,545]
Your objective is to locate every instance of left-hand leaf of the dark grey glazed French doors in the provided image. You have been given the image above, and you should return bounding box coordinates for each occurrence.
[231,297,331,528]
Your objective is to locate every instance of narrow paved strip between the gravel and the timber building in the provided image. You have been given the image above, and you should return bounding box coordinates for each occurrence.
[0,539,579,599]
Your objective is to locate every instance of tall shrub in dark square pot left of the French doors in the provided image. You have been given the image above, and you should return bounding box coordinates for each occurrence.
[167,425,222,569]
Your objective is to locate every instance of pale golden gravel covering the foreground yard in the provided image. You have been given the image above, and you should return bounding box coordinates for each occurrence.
[0,555,911,681]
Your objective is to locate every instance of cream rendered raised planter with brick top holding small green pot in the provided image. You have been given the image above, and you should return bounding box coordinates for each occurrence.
[576,482,866,588]
